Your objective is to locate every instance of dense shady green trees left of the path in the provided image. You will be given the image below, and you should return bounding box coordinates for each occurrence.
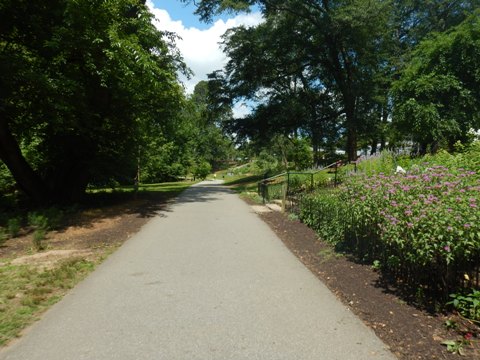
[0,0,235,204]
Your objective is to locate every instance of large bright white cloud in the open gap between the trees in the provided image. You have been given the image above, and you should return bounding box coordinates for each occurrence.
[147,0,263,93]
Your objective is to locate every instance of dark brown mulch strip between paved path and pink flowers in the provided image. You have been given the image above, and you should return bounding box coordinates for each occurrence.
[253,207,480,359]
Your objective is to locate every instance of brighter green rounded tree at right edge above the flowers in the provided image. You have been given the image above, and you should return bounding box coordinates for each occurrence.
[394,11,480,152]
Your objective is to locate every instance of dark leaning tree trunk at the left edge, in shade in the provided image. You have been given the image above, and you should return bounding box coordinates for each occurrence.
[0,116,50,204]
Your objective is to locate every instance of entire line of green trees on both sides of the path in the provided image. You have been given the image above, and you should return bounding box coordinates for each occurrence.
[0,0,480,203]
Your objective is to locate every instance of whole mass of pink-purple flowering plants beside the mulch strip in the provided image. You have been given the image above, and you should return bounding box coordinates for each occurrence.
[300,145,480,296]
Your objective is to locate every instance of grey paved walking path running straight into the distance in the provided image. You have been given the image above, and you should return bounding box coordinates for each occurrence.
[0,182,394,360]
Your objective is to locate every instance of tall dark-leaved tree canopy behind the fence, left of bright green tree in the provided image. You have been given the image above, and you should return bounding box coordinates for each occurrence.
[185,0,480,160]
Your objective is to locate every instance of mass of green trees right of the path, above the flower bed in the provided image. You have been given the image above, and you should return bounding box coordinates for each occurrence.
[191,0,480,164]
